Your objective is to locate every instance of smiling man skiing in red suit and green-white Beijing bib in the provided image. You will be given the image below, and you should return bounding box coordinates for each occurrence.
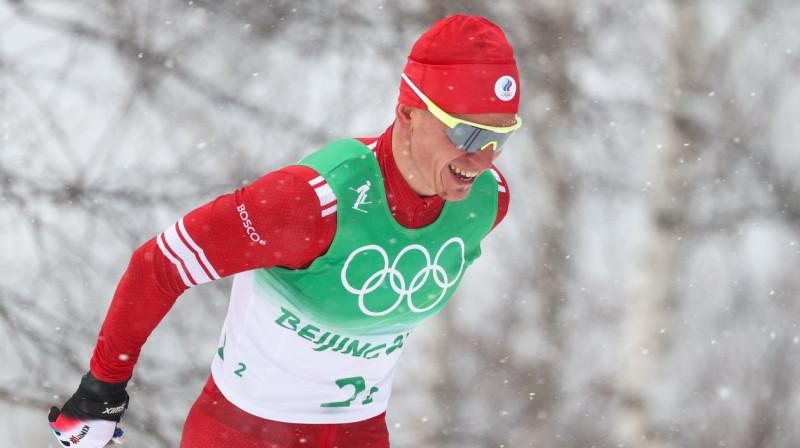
[50,15,521,448]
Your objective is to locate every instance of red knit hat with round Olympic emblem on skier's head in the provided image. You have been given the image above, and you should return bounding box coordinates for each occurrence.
[399,15,519,114]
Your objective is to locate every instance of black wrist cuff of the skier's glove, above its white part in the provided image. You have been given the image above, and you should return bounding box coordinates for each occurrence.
[61,372,129,422]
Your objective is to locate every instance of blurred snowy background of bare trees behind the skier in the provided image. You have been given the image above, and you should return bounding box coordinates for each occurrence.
[0,0,800,448]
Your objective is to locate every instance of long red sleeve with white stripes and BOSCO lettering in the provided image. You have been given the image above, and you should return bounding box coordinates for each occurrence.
[90,166,336,382]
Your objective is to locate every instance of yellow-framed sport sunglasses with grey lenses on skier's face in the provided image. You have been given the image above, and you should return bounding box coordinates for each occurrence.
[401,73,522,153]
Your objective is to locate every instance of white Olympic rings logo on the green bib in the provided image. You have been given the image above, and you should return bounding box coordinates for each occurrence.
[342,237,465,316]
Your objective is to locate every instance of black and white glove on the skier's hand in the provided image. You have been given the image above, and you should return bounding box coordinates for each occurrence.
[47,372,128,448]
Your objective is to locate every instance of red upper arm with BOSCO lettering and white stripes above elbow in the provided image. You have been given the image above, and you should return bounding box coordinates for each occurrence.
[158,166,336,287]
